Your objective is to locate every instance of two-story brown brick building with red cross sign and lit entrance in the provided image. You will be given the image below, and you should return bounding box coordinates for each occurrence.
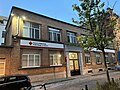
[0,7,115,81]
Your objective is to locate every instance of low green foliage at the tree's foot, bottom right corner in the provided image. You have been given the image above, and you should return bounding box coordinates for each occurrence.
[96,81,120,90]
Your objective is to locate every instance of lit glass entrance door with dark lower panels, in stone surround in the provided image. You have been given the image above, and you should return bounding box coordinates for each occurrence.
[69,53,80,76]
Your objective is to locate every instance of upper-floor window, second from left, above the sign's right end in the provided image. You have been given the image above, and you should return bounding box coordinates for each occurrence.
[48,28,61,42]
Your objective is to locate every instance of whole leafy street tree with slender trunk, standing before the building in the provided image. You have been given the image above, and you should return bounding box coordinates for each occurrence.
[72,0,116,83]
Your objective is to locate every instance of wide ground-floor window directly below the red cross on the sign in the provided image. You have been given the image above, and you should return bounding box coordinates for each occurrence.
[22,49,41,67]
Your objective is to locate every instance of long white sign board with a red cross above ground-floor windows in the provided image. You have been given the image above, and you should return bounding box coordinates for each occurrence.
[20,40,64,49]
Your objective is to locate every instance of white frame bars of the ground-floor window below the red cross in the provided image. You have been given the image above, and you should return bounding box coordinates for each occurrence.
[22,54,41,68]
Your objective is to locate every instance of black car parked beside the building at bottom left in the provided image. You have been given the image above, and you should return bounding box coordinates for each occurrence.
[0,74,31,90]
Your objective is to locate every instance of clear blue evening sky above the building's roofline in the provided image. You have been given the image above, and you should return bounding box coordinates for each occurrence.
[0,0,120,23]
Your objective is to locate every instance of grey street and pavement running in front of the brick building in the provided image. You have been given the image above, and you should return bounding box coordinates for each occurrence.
[32,71,120,90]
